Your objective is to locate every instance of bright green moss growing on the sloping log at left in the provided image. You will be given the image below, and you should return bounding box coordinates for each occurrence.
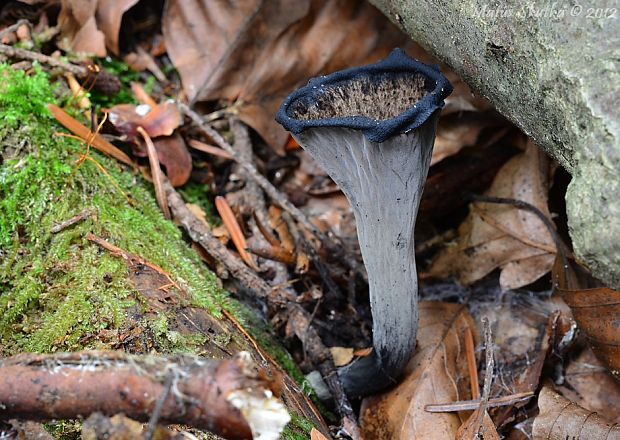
[0,65,226,355]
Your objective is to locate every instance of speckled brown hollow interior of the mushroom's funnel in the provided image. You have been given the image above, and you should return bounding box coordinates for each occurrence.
[288,72,432,121]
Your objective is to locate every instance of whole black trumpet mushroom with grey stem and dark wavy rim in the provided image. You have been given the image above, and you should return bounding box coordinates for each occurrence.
[276,49,452,397]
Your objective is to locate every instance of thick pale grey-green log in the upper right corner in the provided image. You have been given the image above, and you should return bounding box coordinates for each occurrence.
[371,0,620,288]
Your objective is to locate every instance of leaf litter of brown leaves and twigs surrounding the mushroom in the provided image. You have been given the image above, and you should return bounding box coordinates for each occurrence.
[3,0,620,440]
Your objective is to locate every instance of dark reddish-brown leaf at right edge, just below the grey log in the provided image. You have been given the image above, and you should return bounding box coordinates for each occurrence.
[561,287,620,380]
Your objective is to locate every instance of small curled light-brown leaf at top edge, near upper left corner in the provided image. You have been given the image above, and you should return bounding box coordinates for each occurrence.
[58,0,138,57]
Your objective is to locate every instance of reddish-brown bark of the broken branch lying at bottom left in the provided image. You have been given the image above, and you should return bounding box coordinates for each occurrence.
[0,352,280,439]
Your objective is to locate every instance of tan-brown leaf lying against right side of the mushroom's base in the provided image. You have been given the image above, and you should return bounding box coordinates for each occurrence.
[361,302,475,440]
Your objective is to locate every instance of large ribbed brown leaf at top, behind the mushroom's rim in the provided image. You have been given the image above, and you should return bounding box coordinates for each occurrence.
[163,0,408,151]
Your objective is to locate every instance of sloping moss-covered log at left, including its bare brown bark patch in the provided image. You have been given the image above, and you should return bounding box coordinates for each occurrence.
[0,65,324,438]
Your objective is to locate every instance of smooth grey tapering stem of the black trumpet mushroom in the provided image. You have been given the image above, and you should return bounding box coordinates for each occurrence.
[295,114,437,396]
